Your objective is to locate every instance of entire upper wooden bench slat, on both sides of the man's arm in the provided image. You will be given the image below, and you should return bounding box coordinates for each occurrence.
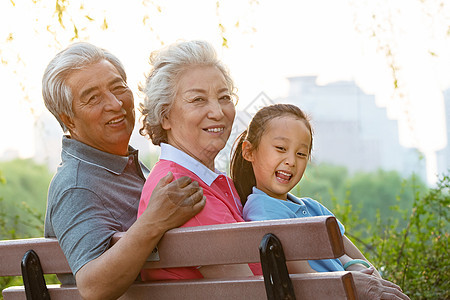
[0,216,344,276]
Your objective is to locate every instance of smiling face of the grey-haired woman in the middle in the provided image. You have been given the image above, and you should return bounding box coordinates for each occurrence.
[162,66,236,170]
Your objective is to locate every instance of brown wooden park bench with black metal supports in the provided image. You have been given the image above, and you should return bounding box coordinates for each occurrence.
[0,216,356,300]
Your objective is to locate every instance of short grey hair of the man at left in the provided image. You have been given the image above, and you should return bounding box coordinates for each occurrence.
[42,42,127,132]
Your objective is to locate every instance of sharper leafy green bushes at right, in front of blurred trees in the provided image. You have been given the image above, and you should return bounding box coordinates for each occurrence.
[326,175,450,299]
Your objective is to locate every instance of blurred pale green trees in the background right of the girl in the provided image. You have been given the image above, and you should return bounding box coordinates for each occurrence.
[293,164,426,229]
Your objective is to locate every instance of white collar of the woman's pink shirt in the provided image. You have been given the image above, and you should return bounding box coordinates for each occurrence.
[159,143,224,186]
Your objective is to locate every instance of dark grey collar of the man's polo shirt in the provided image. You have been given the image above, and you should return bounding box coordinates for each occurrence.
[62,135,138,175]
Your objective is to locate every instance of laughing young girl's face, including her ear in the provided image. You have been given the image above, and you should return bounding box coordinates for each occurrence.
[242,116,311,200]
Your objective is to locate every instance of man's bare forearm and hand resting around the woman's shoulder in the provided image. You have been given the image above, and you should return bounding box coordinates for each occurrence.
[76,173,206,299]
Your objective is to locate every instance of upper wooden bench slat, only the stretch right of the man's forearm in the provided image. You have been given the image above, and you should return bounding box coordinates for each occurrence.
[114,216,344,268]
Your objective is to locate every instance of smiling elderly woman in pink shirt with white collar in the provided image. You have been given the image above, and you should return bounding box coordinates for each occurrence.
[138,41,261,280]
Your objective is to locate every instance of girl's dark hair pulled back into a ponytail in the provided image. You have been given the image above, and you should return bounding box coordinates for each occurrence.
[230,104,313,205]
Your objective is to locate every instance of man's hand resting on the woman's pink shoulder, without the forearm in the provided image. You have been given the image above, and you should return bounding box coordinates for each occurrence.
[140,172,206,232]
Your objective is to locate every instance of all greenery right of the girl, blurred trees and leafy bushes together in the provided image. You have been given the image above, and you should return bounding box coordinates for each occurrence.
[294,165,450,299]
